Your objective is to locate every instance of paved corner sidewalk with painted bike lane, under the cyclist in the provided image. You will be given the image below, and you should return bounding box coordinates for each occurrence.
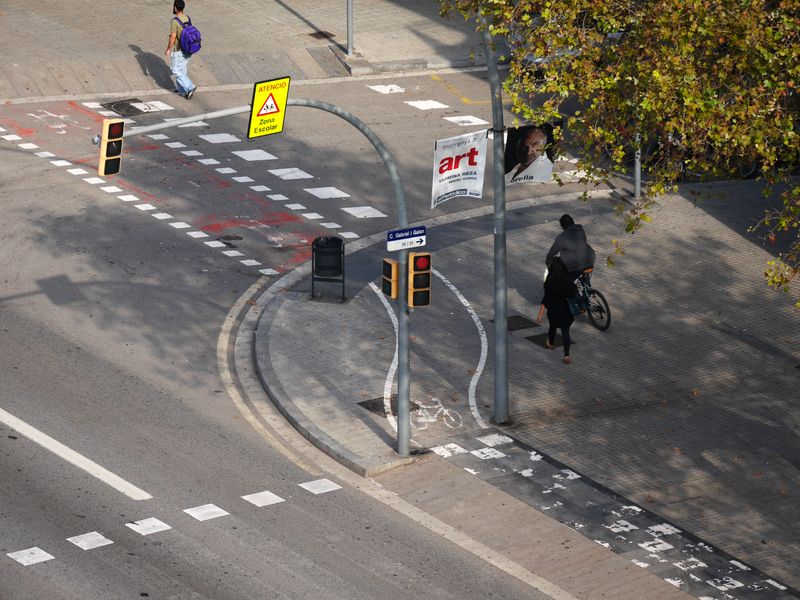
[253,183,800,598]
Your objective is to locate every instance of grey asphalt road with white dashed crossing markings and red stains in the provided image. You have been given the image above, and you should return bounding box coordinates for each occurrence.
[0,73,564,599]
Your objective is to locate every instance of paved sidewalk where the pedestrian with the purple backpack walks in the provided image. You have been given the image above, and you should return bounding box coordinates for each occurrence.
[0,0,485,102]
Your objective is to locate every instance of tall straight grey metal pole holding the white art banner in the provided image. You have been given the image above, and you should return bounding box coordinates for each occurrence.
[481,26,509,425]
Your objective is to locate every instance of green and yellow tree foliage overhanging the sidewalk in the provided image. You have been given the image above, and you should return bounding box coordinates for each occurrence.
[440,0,800,305]
